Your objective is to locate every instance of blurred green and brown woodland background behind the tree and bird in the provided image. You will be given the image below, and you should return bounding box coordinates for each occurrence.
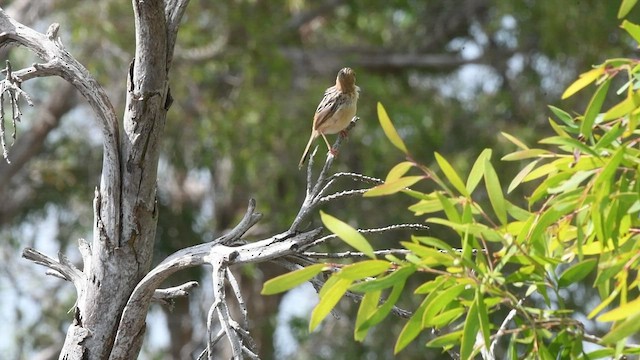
[0,0,638,359]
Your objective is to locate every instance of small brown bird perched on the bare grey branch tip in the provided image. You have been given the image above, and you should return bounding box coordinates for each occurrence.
[298,68,360,168]
